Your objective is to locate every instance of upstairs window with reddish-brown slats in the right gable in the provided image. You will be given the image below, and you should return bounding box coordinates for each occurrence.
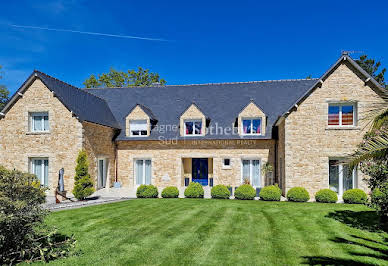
[328,104,355,126]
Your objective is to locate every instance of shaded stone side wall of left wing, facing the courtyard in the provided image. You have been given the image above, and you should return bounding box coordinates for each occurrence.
[82,122,116,187]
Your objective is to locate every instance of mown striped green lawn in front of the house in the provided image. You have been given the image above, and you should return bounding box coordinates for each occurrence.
[41,199,388,265]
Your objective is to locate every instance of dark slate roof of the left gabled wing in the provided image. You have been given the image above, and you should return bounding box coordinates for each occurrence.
[2,70,120,129]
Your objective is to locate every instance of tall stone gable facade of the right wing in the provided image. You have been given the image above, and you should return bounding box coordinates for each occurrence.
[278,61,383,195]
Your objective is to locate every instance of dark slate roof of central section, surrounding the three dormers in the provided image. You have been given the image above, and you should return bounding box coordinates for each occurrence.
[86,79,317,140]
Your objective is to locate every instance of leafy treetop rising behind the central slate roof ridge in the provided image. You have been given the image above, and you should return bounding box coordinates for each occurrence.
[83,67,166,88]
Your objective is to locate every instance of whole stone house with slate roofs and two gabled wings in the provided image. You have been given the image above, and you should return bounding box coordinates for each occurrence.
[0,54,385,198]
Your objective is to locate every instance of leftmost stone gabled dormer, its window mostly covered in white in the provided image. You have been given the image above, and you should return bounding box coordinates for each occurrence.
[125,104,157,137]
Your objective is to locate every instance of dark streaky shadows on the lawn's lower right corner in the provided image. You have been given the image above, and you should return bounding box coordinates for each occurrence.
[303,210,388,265]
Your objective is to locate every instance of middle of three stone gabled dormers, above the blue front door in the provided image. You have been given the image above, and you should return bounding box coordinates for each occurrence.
[179,103,207,137]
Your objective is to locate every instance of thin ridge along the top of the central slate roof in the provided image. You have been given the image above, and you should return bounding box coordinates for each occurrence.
[85,78,319,90]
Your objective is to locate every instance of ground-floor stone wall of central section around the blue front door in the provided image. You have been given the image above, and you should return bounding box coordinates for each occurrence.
[118,140,275,188]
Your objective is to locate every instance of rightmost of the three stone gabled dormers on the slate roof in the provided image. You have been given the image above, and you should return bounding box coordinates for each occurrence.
[237,101,267,136]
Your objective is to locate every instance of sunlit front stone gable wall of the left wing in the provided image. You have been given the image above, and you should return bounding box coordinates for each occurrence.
[0,79,82,195]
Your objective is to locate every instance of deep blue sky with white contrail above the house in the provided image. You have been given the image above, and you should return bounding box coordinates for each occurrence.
[0,0,388,92]
